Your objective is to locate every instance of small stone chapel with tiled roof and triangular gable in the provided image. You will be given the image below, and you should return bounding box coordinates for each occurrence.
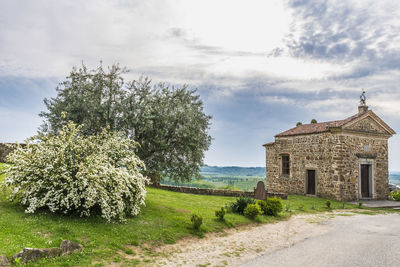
[264,107,395,201]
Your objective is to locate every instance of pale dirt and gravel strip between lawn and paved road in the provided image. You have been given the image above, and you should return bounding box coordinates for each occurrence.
[152,213,333,266]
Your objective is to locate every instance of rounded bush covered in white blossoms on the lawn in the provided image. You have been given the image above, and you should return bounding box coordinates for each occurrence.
[3,122,148,222]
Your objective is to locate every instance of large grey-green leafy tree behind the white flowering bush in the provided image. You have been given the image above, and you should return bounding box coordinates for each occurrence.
[40,62,211,183]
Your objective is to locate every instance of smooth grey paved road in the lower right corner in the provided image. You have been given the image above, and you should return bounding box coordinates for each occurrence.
[240,214,400,267]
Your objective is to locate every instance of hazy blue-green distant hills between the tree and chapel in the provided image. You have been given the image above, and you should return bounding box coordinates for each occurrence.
[200,165,265,177]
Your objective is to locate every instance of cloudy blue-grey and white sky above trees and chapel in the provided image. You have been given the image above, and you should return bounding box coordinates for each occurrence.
[0,0,400,171]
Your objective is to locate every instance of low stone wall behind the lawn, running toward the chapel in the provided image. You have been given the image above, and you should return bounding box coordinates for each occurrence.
[153,185,287,199]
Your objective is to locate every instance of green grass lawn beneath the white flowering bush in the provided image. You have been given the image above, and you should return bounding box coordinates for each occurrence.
[0,165,382,266]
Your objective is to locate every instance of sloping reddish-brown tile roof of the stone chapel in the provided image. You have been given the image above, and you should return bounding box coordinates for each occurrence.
[275,113,365,137]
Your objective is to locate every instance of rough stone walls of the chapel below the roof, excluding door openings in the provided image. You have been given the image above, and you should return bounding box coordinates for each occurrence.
[266,132,388,200]
